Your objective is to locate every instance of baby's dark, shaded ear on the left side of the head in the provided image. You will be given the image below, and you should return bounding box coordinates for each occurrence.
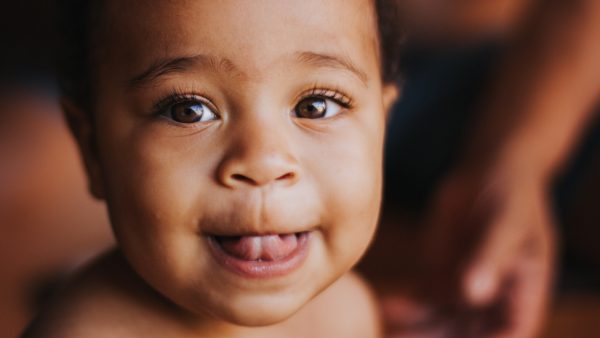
[60,97,104,199]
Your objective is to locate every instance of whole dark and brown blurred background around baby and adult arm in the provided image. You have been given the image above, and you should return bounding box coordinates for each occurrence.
[0,0,600,338]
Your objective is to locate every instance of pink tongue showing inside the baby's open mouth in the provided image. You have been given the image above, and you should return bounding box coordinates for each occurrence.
[218,234,298,261]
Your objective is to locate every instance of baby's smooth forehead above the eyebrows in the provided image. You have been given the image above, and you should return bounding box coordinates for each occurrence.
[95,0,379,84]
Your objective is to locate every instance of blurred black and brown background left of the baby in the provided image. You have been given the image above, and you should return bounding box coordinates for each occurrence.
[0,1,112,338]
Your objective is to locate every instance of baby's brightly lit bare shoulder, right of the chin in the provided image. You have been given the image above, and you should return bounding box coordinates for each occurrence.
[293,272,382,338]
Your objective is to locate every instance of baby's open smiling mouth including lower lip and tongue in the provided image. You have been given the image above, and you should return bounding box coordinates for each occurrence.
[208,232,310,278]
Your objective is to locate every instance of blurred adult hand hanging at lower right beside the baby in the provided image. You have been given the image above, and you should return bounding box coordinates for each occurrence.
[423,162,555,338]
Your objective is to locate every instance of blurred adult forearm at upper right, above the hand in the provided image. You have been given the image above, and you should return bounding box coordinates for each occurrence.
[465,0,600,178]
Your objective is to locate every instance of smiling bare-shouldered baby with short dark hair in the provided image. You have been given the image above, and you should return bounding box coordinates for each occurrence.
[25,0,398,338]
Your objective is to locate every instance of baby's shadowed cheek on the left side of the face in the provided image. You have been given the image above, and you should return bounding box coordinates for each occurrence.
[95,118,214,280]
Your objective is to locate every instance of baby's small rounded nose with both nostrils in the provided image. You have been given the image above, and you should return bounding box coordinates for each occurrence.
[217,119,300,189]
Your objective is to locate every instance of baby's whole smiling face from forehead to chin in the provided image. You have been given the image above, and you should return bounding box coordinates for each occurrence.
[82,0,394,325]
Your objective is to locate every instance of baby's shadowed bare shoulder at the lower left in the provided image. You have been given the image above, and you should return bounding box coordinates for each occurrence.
[22,248,185,338]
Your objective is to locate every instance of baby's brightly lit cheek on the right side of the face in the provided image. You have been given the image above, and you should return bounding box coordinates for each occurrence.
[310,112,384,269]
